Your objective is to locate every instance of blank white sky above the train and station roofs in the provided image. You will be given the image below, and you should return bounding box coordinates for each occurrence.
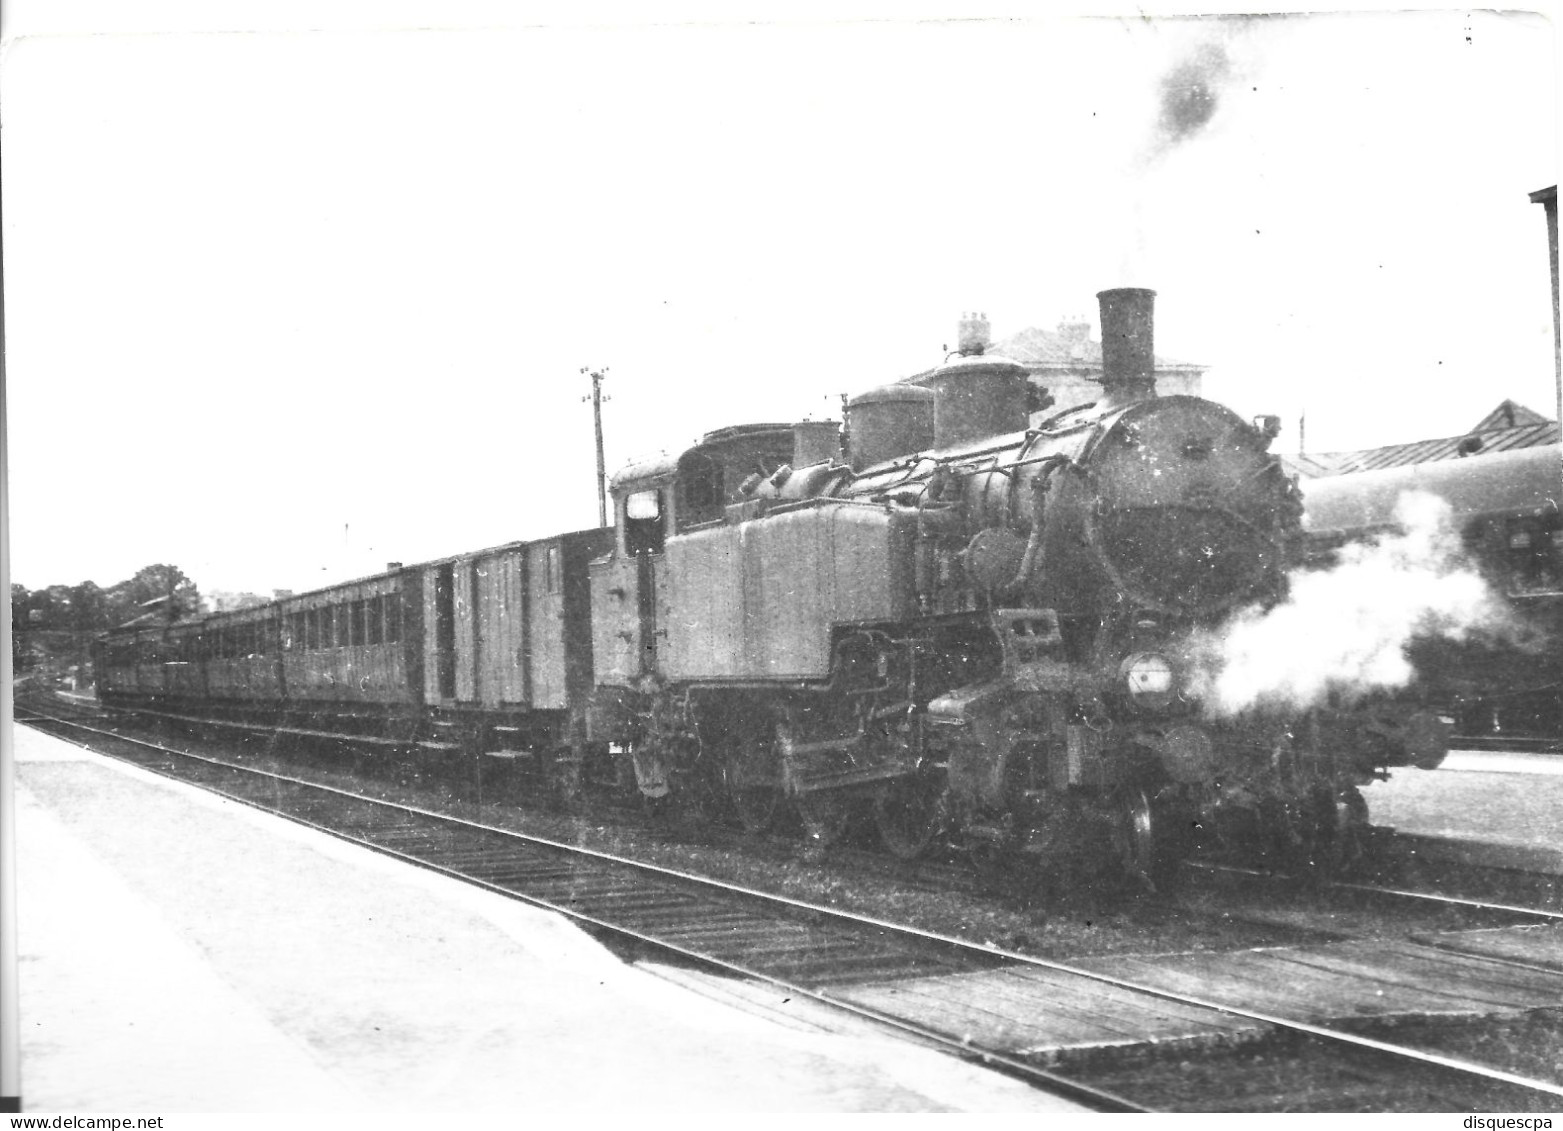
[0,0,1557,592]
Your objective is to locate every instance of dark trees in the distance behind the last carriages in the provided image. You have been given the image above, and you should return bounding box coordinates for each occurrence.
[11,562,202,675]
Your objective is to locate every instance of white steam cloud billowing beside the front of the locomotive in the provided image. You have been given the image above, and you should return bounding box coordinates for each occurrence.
[1189,494,1518,714]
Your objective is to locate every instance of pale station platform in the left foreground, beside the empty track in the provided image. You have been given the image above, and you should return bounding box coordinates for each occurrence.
[14,726,1082,1115]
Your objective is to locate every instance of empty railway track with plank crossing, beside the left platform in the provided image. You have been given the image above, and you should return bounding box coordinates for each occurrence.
[19,702,1563,1111]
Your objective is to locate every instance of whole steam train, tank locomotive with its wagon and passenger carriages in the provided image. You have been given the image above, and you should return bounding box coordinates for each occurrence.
[97,289,1446,876]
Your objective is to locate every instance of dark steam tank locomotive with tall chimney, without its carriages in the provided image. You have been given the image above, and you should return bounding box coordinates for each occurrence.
[588,289,1444,876]
